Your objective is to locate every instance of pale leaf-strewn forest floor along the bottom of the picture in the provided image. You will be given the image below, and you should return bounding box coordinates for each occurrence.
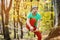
[0,35,60,40]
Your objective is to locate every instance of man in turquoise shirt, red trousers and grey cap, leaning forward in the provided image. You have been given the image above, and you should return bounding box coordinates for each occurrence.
[27,6,41,40]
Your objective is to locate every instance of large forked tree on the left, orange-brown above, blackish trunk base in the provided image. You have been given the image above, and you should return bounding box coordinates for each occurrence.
[1,0,12,40]
